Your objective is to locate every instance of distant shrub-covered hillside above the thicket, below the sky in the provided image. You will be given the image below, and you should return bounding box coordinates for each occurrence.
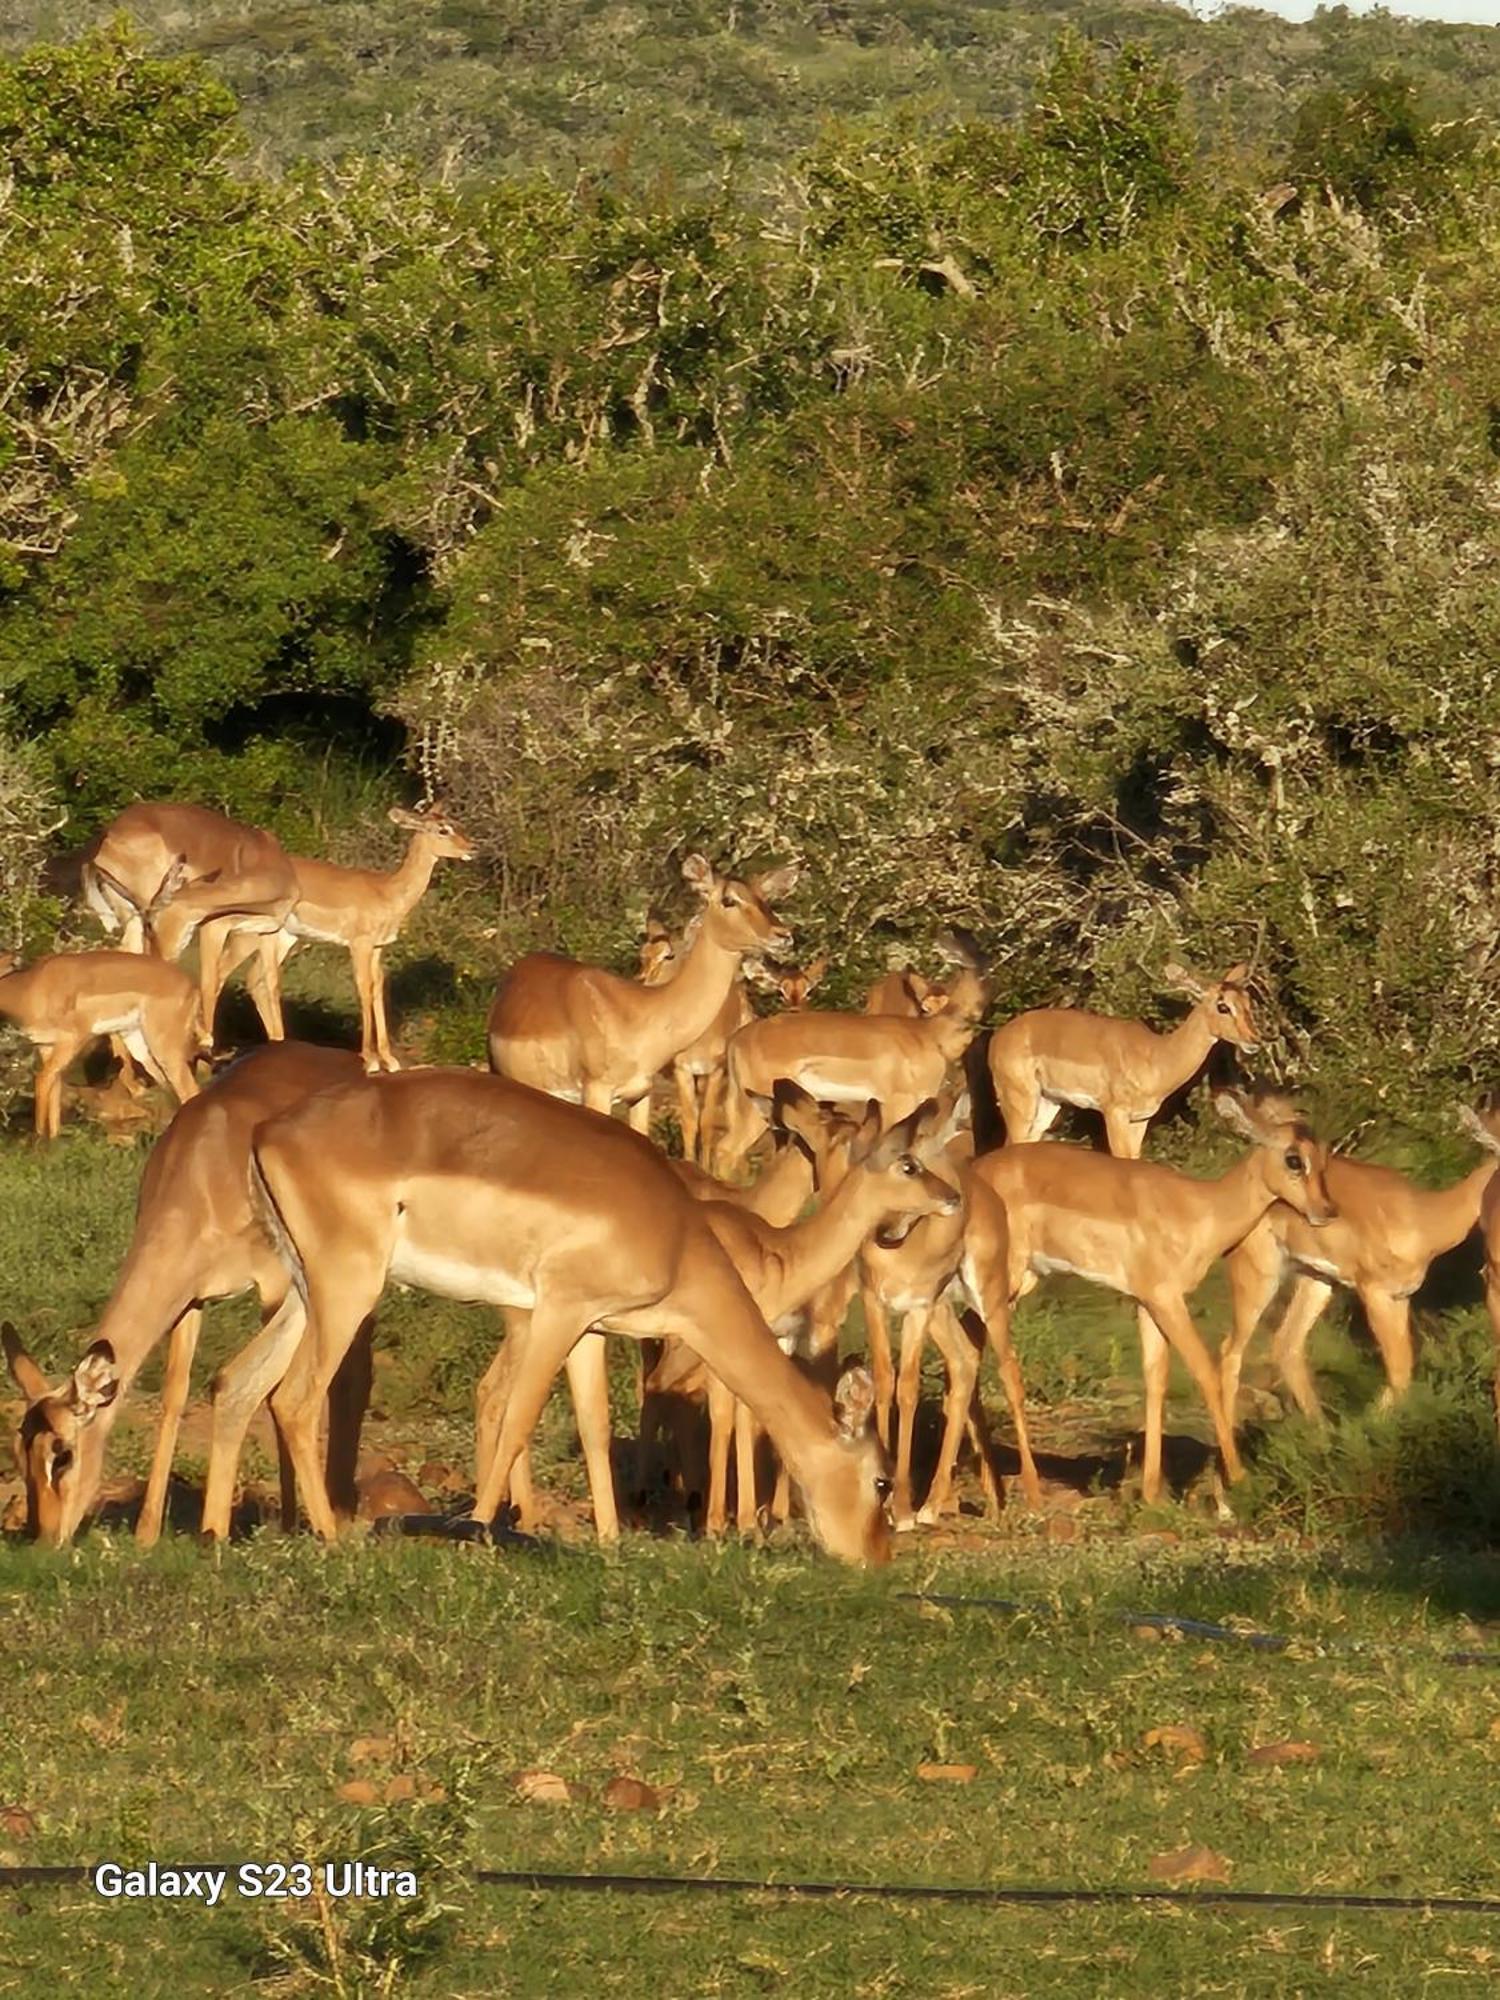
[0,0,1500,184]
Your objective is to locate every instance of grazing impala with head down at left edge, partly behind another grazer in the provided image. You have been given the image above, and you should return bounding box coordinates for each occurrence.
[0,1040,368,1546]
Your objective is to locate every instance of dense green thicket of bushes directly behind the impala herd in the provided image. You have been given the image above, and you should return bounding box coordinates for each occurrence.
[0,19,1500,1132]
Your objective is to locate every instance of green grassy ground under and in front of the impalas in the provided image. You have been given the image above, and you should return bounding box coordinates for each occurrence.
[0,968,1500,1996]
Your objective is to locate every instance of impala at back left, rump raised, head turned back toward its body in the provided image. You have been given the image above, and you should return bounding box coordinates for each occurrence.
[82,802,296,1042]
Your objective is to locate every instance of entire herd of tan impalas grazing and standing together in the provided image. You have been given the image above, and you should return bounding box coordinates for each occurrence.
[0,804,1500,1562]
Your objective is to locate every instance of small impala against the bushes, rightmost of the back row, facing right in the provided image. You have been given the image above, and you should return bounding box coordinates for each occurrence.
[990,966,1258,1160]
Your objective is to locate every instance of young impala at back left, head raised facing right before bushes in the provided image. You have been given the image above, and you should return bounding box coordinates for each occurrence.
[224,804,474,1072]
